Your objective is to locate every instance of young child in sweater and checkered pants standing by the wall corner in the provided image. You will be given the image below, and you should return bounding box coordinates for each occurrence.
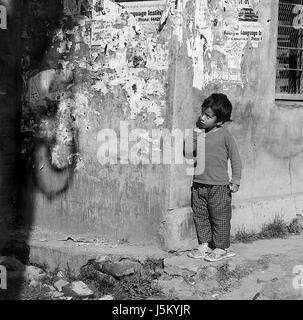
[185,93,241,261]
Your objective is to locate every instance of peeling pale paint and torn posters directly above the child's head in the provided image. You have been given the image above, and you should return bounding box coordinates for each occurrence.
[187,0,262,89]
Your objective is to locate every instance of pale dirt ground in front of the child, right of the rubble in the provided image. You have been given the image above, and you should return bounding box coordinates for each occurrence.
[159,235,303,300]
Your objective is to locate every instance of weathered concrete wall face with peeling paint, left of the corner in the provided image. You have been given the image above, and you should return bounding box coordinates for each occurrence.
[22,0,173,243]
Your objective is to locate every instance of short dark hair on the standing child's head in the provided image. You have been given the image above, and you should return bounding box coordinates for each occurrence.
[202,93,233,122]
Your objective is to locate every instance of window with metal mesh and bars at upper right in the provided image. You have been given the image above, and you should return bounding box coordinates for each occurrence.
[276,0,303,100]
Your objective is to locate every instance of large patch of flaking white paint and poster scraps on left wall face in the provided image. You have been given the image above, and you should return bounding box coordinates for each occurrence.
[22,0,169,172]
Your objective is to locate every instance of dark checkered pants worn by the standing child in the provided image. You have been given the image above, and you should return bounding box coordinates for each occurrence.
[192,183,231,249]
